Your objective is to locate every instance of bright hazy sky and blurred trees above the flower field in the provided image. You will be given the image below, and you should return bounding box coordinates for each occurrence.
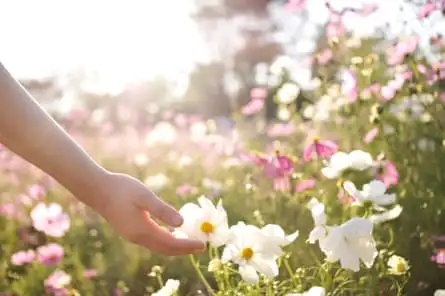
[0,0,445,121]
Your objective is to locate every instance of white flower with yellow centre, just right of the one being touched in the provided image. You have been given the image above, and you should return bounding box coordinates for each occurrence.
[222,222,282,284]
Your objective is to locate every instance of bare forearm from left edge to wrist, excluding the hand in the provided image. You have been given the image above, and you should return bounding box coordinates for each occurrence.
[0,63,106,204]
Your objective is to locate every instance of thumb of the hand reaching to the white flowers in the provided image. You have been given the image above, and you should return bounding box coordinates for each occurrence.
[136,189,184,227]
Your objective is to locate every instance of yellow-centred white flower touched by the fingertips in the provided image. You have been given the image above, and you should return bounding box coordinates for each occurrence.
[175,196,229,247]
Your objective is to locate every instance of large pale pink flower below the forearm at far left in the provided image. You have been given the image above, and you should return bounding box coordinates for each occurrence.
[31,202,70,237]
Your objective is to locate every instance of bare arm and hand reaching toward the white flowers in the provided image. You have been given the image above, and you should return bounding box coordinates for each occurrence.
[0,63,205,255]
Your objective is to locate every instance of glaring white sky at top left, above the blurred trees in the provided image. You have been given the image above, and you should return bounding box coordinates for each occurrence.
[0,0,206,82]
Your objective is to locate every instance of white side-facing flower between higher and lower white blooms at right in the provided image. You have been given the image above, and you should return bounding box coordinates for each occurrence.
[343,180,396,206]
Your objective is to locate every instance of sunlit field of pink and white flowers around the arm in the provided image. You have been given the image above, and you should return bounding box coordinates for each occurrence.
[4,0,445,296]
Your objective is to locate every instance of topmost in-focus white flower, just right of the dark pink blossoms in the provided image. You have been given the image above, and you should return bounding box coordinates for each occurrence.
[321,150,373,179]
